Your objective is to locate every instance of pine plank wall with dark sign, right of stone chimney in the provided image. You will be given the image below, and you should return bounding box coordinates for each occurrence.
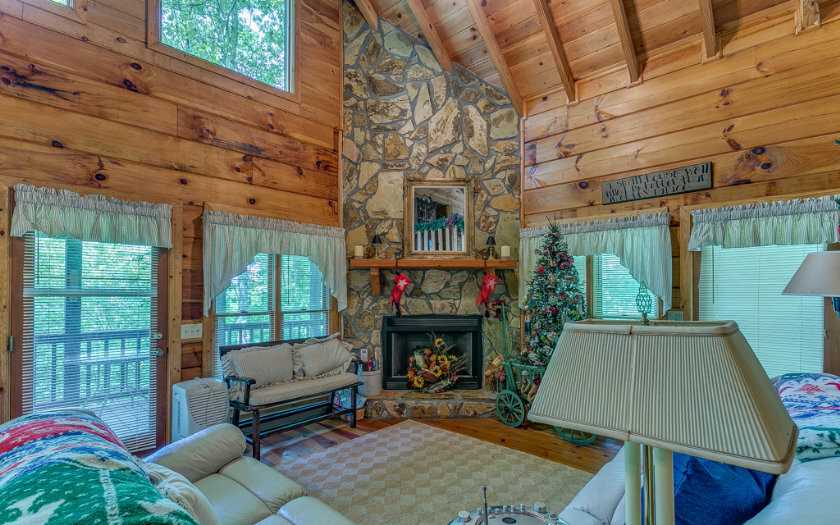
[522,8,840,314]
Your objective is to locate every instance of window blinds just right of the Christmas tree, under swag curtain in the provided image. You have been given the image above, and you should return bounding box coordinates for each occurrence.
[592,254,660,319]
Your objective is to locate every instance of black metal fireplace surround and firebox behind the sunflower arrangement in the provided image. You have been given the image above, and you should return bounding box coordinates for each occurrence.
[382,315,484,390]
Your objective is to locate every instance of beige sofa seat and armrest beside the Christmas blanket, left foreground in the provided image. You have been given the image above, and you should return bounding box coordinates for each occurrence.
[145,424,354,525]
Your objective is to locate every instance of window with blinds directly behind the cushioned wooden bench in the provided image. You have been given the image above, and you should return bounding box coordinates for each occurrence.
[214,253,331,376]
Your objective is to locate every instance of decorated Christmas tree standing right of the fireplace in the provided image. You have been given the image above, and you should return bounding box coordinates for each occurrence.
[528,224,586,365]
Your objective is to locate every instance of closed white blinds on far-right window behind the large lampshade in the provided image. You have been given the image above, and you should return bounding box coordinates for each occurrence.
[700,244,825,377]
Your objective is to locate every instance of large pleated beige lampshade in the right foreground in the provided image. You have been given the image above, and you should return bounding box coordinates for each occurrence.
[528,321,797,474]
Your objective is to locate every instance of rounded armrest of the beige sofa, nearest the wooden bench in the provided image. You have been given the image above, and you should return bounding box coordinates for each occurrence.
[145,423,245,482]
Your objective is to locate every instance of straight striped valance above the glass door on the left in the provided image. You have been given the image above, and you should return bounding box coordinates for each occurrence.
[11,184,172,248]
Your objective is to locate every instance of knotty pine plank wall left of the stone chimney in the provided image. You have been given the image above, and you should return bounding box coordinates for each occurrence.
[0,0,341,379]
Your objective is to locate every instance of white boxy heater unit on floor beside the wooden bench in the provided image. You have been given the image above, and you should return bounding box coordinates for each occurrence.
[172,378,228,441]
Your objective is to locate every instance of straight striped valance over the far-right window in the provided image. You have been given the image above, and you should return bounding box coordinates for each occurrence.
[688,196,840,251]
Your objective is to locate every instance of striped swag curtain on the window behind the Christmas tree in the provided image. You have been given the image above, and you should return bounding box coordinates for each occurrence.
[519,210,672,312]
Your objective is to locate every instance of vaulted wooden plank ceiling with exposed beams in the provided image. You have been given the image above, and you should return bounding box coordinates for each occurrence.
[356,0,837,111]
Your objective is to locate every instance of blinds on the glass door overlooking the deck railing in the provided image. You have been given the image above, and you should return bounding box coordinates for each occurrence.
[19,234,162,451]
